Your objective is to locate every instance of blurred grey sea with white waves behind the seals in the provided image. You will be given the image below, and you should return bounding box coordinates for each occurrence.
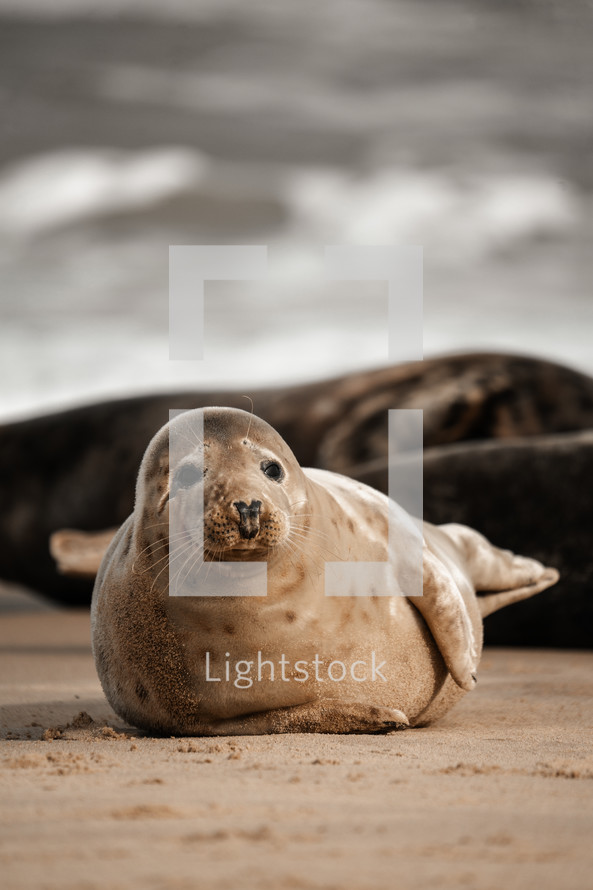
[0,0,593,417]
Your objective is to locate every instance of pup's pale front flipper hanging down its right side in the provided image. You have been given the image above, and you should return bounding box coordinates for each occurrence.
[409,547,478,692]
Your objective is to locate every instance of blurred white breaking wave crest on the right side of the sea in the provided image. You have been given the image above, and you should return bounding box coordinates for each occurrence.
[286,169,582,262]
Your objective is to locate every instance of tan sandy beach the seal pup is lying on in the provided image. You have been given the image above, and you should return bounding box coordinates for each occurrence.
[0,594,593,890]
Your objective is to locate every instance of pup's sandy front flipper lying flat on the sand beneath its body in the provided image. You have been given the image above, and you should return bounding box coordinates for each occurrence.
[196,699,410,736]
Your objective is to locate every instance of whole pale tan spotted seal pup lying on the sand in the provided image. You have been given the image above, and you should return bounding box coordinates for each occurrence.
[91,408,558,735]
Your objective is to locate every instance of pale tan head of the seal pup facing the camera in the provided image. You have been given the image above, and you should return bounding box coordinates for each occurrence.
[136,408,307,561]
